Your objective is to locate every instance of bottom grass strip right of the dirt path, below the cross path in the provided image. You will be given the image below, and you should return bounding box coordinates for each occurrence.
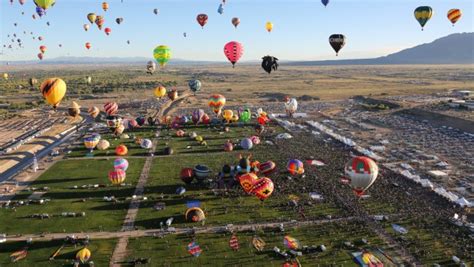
[129,222,388,266]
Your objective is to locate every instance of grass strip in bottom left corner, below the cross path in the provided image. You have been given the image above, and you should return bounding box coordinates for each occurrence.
[0,240,116,267]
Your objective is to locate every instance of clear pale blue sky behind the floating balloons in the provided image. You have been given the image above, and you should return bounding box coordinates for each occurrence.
[0,0,474,61]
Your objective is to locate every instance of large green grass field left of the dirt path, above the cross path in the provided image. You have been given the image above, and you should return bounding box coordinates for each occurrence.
[0,159,144,234]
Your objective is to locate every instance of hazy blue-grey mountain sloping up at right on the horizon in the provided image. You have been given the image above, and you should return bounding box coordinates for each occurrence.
[289,32,474,65]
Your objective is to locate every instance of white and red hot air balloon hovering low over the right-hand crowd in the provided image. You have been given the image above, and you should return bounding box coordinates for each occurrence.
[344,156,379,196]
